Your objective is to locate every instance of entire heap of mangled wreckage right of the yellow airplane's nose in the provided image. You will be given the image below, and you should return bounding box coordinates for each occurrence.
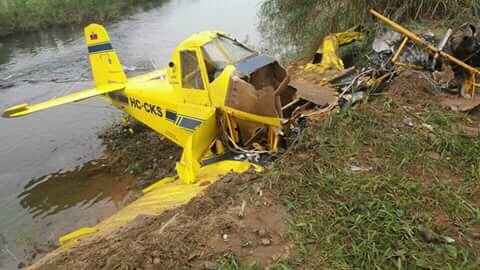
[284,10,480,130]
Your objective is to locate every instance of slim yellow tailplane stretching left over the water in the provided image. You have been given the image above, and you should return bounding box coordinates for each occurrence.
[2,83,125,118]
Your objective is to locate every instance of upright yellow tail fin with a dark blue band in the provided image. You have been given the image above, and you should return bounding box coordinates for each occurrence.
[85,24,127,87]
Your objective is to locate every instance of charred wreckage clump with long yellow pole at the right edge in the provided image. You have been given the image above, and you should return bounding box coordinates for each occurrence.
[370,10,480,97]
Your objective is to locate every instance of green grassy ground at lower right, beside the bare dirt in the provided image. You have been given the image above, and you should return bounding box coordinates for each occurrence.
[255,98,480,270]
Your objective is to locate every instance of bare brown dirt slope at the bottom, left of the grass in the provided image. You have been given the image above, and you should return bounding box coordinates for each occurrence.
[31,170,293,269]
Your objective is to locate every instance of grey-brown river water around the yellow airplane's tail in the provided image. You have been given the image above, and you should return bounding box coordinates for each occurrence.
[0,0,260,269]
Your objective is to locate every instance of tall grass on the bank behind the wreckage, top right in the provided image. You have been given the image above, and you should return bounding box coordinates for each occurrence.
[260,0,480,61]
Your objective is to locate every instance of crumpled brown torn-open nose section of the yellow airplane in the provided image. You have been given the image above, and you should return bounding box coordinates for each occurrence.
[220,59,296,152]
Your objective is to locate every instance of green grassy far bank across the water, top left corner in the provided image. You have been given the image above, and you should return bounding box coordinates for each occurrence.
[0,0,169,37]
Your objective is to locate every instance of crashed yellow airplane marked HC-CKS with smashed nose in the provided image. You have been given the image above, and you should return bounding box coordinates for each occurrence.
[2,24,294,184]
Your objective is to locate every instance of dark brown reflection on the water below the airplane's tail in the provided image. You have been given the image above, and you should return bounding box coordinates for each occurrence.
[18,162,138,218]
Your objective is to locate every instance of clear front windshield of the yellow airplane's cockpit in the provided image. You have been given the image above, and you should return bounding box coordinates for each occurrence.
[202,36,256,82]
